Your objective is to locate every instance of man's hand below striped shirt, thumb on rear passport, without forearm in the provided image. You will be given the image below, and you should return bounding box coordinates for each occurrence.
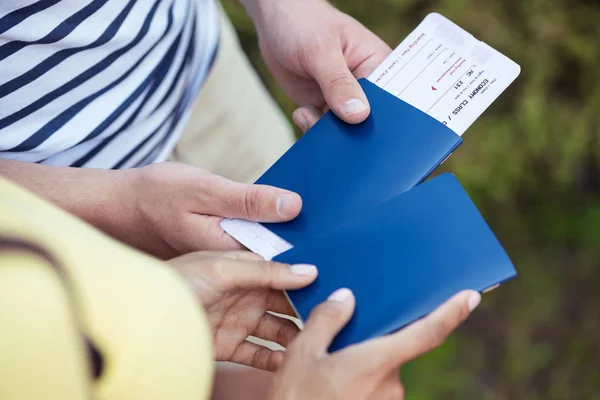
[121,163,302,259]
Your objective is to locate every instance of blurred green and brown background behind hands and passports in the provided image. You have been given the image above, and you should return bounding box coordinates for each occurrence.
[224,0,600,400]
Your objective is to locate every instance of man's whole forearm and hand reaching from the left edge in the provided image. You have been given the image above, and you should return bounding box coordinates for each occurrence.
[0,159,302,259]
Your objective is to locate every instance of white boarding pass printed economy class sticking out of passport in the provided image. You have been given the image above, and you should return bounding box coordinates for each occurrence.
[368,13,521,135]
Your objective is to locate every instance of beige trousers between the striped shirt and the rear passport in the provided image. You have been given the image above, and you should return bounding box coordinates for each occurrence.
[170,6,294,183]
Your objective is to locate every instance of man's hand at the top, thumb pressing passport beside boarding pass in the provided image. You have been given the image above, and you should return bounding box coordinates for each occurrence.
[241,0,391,131]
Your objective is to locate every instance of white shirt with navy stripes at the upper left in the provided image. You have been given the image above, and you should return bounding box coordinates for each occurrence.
[0,0,219,168]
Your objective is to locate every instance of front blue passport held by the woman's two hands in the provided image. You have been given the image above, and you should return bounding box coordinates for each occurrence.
[274,174,516,351]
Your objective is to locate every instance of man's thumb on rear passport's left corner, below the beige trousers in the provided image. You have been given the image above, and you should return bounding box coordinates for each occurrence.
[198,176,302,222]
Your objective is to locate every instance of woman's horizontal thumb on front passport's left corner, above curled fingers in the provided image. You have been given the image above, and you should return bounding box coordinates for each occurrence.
[213,258,318,290]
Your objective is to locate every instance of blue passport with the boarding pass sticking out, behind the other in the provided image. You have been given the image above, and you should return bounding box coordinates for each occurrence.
[256,79,462,245]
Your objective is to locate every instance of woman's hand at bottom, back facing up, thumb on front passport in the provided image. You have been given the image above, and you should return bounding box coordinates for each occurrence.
[269,289,481,400]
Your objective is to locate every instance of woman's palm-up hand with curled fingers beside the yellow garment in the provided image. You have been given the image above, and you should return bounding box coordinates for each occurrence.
[168,251,317,371]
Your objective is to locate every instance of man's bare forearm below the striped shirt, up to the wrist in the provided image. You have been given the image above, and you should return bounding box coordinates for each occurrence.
[0,159,134,244]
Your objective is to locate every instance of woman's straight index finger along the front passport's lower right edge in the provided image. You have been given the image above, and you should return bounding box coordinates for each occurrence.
[361,290,481,373]
